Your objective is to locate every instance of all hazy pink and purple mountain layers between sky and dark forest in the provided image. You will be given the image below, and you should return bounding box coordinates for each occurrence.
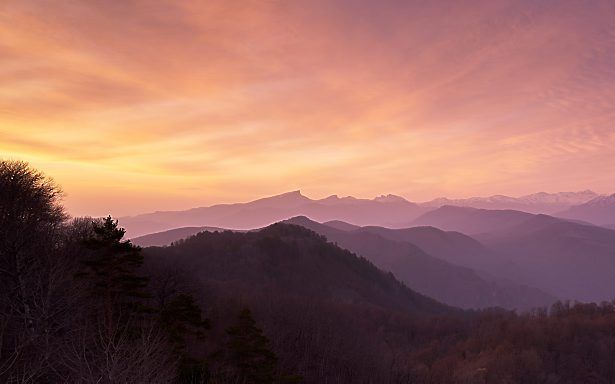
[127,191,615,308]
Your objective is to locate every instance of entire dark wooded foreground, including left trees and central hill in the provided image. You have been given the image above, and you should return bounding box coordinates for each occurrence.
[0,161,615,384]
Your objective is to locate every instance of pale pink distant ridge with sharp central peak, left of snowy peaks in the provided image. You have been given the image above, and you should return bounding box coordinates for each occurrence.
[119,191,428,238]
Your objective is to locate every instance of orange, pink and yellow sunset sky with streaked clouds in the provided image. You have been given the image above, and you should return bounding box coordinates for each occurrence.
[0,0,615,216]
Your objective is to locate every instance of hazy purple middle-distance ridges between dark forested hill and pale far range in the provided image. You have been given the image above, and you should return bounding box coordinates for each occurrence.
[134,206,615,308]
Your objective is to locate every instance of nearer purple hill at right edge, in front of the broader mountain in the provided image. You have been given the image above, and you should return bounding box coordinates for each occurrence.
[478,215,615,302]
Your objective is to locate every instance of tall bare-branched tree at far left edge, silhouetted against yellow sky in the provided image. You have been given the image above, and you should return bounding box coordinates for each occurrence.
[0,160,69,382]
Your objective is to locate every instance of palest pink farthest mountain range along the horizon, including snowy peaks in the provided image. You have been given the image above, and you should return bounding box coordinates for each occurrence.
[120,191,598,237]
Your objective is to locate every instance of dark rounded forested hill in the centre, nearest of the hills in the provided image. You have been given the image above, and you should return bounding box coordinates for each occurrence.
[145,223,458,314]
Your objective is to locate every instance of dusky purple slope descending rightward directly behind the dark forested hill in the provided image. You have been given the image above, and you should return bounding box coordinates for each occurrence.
[287,217,555,309]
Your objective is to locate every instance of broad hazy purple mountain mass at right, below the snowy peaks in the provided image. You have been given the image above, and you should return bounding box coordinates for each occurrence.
[406,206,615,302]
